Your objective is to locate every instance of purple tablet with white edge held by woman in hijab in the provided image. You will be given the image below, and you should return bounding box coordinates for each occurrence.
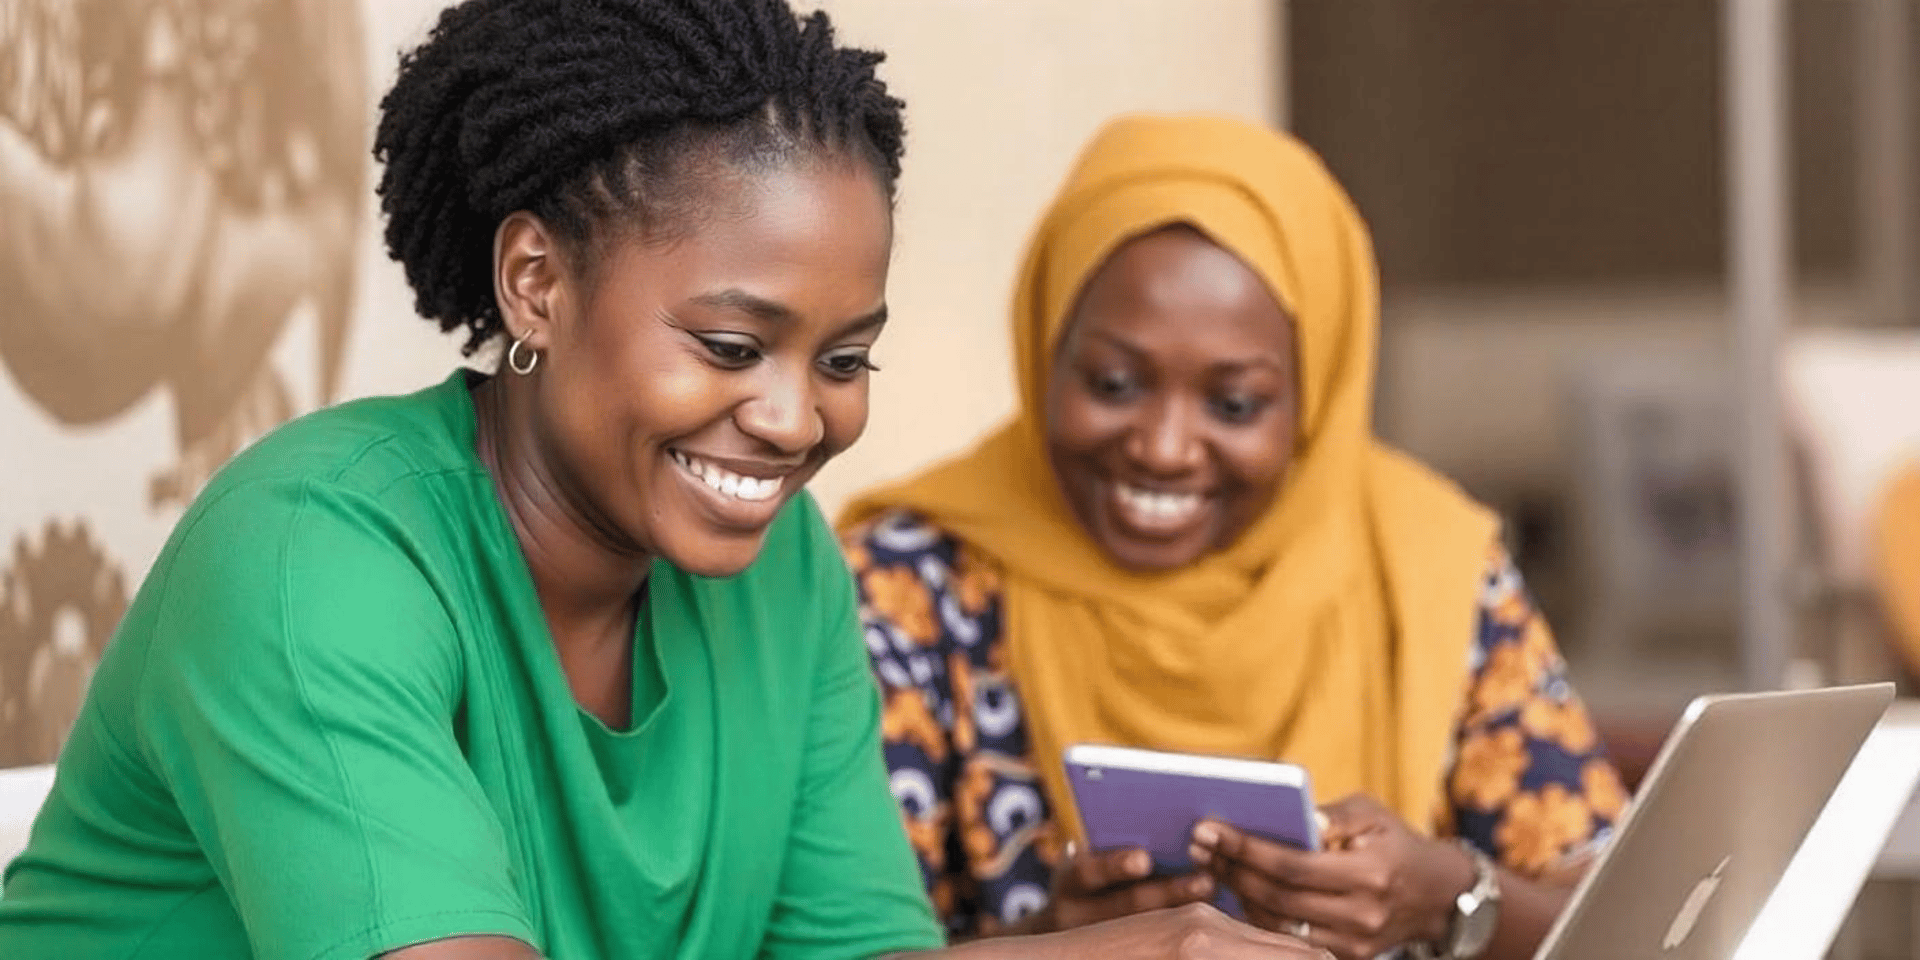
[1066,751,1319,916]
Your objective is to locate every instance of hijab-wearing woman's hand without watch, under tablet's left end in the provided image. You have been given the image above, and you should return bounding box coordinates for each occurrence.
[1010,843,1213,933]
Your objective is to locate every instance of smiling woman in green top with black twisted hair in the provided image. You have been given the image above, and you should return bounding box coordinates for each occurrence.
[0,0,1306,960]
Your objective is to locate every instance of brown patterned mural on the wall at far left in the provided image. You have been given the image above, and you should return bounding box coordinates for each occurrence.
[0,0,371,766]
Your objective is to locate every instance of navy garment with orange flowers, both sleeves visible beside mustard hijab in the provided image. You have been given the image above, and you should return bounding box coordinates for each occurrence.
[847,511,1626,935]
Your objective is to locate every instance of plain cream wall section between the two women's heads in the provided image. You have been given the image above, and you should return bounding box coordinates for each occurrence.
[814,0,1281,509]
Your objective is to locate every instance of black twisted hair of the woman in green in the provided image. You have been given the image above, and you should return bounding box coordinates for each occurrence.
[374,0,904,353]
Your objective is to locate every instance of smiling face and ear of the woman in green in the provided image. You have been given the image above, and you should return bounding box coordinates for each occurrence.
[501,159,893,576]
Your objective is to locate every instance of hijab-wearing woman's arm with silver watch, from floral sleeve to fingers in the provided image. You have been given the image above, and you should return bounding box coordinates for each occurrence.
[1196,553,1624,960]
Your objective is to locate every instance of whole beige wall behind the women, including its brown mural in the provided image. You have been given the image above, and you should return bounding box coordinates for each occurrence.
[0,0,1279,766]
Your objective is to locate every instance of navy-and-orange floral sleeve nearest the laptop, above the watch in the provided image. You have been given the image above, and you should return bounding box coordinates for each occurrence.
[1448,551,1626,876]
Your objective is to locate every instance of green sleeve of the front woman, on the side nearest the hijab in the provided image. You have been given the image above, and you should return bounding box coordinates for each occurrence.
[762,503,943,958]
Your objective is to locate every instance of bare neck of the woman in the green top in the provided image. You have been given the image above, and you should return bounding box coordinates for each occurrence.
[472,376,651,655]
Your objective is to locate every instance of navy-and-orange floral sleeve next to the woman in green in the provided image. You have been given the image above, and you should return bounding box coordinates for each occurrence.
[847,511,1062,939]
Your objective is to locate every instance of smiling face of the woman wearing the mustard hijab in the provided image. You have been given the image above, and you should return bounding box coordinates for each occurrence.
[1046,227,1298,572]
